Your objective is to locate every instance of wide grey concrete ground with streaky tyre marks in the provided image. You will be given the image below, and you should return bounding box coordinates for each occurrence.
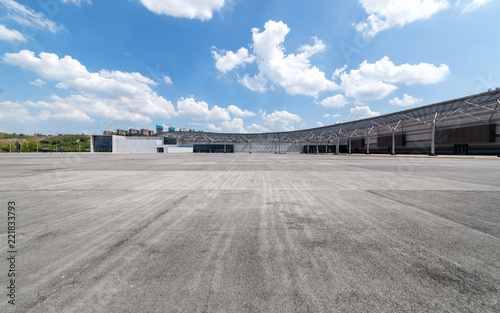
[0,154,500,312]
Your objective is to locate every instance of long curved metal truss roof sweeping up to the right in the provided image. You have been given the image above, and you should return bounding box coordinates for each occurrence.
[158,88,500,144]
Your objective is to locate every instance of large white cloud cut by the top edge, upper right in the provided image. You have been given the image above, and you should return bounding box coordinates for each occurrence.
[355,0,450,37]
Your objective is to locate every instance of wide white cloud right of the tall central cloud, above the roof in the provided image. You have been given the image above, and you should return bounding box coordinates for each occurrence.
[339,57,450,100]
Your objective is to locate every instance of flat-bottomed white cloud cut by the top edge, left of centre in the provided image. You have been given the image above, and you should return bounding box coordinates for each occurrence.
[140,0,225,20]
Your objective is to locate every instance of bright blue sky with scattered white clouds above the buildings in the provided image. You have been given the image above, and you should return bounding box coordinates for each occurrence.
[0,0,500,134]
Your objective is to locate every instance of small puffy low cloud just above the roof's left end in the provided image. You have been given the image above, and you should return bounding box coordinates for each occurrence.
[177,98,231,122]
